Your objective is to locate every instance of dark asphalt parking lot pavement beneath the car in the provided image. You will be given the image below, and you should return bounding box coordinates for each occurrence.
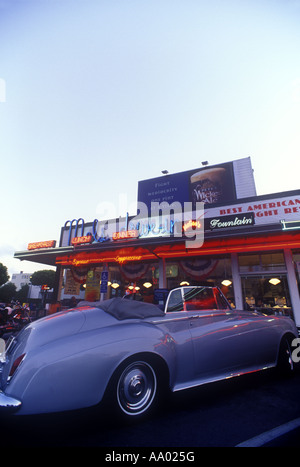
[1,371,300,455]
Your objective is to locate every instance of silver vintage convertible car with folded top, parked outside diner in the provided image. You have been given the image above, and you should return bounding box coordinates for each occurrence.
[0,287,298,419]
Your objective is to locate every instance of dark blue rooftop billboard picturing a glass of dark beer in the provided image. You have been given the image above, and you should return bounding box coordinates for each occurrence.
[138,162,237,210]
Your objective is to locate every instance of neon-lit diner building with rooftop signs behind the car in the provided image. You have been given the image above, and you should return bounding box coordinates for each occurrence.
[15,158,300,328]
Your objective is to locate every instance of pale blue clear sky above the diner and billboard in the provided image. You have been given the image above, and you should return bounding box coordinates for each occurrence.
[0,0,300,274]
